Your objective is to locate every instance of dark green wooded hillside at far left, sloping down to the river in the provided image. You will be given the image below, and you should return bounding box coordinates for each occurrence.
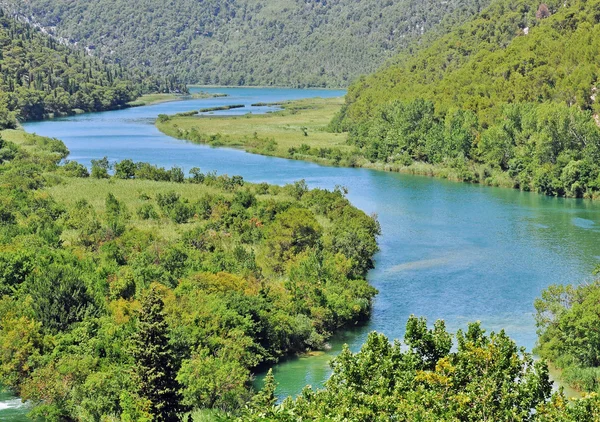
[0,9,185,129]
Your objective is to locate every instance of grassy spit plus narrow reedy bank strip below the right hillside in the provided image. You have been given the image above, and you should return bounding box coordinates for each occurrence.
[156,98,598,199]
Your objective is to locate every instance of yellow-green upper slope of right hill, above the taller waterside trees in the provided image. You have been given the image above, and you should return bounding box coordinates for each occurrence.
[332,0,584,125]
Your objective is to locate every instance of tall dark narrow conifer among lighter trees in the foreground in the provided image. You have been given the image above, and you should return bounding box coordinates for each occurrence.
[133,288,184,422]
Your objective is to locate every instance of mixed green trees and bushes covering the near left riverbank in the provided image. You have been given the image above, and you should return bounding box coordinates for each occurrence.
[0,131,380,421]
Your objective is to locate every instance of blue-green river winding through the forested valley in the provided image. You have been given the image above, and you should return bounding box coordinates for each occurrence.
[0,88,600,420]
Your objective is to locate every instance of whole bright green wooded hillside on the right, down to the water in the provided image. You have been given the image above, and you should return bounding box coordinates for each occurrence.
[331,0,600,197]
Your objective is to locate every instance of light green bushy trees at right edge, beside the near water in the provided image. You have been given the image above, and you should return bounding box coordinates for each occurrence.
[535,281,600,393]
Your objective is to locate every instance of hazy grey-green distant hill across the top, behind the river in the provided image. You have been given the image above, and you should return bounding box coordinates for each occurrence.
[3,0,489,87]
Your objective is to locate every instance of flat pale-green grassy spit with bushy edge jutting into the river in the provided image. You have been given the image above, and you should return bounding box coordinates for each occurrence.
[156,98,356,166]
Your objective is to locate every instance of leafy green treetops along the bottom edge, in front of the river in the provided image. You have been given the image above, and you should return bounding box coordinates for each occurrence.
[243,317,600,422]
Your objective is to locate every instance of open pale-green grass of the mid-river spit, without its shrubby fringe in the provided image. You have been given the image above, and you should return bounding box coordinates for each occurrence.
[156,98,352,157]
